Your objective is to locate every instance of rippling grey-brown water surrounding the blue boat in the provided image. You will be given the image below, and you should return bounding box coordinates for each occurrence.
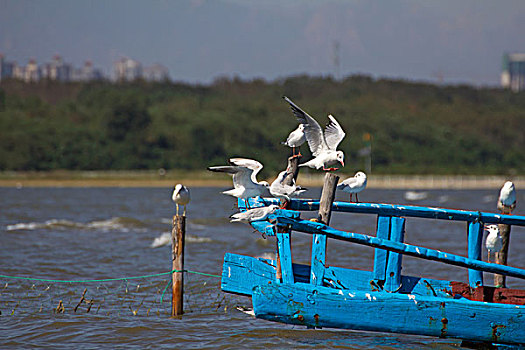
[0,188,525,349]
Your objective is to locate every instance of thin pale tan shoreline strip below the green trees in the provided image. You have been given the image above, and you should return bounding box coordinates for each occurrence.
[0,171,525,190]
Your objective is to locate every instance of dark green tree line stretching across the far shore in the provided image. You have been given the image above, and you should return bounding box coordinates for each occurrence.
[0,76,525,175]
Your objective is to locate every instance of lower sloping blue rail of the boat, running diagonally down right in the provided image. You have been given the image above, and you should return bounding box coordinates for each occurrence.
[278,217,525,279]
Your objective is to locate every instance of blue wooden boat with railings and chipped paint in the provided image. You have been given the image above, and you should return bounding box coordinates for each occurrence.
[221,197,525,346]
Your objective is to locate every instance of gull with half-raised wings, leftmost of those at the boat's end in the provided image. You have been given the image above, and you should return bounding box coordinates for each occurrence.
[208,158,270,205]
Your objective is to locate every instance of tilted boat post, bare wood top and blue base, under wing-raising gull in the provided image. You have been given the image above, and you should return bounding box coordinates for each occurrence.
[310,173,339,286]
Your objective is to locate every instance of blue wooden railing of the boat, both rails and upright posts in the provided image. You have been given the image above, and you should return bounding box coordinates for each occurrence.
[239,197,525,291]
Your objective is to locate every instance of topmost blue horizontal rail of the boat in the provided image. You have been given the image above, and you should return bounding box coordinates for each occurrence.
[250,198,525,226]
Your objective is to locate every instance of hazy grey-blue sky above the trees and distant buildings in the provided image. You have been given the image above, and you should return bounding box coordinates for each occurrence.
[0,0,525,86]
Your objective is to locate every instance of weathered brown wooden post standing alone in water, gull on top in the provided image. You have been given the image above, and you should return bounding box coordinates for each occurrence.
[171,215,186,317]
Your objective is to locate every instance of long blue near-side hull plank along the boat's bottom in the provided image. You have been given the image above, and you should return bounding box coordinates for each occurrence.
[252,283,525,344]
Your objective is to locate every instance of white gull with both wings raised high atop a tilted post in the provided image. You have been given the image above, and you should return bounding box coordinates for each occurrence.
[283,96,345,171]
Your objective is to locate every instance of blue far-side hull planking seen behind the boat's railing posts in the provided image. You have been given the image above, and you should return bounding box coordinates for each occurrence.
[221,253,454,298]
